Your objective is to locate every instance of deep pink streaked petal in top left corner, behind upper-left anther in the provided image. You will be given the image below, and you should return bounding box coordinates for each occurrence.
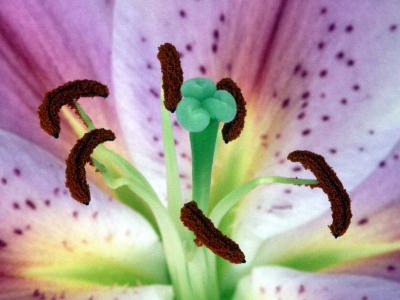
[0,0,126,157]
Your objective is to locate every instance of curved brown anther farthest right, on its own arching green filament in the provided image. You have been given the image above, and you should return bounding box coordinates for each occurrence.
[288,150,352,238]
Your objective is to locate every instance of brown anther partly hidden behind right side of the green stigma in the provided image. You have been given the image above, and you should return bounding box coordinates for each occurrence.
[217,78,246,143]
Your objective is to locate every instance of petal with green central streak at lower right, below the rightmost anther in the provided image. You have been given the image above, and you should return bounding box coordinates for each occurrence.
[241,144,400,288]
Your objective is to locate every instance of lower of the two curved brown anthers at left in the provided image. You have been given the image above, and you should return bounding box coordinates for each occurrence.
[65,128,115,205]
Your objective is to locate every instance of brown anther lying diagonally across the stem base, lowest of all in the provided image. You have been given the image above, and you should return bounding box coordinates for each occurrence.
[181,201,246,264]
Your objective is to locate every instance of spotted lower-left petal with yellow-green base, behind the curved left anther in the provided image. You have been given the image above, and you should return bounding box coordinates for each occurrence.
[0,130,168,299]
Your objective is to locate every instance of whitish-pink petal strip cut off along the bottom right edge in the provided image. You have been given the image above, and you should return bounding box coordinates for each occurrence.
[234,267,400,300]
